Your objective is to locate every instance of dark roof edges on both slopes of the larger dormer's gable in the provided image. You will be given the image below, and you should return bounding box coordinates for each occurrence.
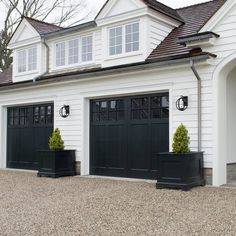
[95,0,183,22]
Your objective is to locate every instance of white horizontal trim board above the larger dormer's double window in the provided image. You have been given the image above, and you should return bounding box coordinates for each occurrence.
[96,7,147,27]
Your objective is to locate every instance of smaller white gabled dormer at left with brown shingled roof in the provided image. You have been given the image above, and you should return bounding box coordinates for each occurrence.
[8,17,61,83]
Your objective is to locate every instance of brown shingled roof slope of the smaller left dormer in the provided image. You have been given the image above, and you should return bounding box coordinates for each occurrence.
[23,16,63,35]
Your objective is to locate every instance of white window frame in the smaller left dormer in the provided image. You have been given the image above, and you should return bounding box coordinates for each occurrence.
[16,46,38,75]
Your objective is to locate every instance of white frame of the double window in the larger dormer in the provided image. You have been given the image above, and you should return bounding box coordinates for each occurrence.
[106,20,141,59]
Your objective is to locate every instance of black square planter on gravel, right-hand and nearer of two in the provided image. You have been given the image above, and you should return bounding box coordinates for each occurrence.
[156,152,205,191]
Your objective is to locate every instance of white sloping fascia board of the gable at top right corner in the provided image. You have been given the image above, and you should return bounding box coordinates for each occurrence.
[199,0,236,33]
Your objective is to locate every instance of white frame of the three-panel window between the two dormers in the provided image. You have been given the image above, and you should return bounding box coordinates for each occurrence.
[53,32,95,70]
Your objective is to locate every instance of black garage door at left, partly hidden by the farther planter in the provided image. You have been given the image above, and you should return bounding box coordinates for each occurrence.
[7,104,53,170]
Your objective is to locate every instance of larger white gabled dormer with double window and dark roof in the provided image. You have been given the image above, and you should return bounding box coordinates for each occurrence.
[95,0,183,67]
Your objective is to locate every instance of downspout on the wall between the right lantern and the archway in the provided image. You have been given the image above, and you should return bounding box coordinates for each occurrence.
[190,60,202,152]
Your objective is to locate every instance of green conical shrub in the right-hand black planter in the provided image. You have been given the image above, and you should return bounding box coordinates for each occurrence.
[172,124,190,153]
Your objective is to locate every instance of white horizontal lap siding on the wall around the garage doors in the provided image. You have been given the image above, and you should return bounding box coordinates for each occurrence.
[0,64,216,166]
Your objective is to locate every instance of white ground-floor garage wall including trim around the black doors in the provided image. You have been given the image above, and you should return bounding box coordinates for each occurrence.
[0,62,212,175]
